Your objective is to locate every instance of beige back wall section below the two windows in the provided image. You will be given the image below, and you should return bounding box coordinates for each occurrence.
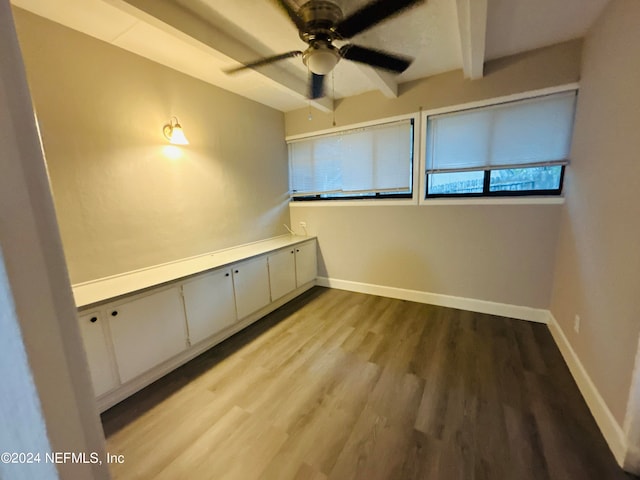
[290,205,560,308]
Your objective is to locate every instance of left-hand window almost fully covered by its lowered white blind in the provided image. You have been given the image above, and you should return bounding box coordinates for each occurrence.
[289,119,414,201]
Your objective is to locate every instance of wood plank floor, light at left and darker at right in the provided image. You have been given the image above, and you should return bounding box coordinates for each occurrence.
[103,287,635,480]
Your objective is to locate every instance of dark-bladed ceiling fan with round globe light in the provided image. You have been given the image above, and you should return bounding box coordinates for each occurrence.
[225,0,425,99]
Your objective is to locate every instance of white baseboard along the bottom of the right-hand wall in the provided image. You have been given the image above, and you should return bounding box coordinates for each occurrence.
[547,312,628,467]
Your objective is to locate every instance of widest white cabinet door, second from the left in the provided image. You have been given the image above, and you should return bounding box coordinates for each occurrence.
[108,288,187,383]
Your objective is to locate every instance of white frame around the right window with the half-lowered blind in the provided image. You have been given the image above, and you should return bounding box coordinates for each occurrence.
[415,83,580,206]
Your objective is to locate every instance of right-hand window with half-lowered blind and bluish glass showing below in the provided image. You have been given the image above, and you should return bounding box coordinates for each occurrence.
[426,91,576,198]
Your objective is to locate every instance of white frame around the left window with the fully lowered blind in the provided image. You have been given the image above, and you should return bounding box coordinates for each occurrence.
[285,112,423,208]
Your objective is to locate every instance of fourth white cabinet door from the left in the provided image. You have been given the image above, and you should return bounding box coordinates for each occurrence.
[233,257,271,320]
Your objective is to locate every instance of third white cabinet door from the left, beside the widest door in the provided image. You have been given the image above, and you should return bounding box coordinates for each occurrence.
[182,268,236,345]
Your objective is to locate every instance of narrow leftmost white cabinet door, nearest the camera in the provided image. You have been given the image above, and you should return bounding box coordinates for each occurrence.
[78,312,118,397]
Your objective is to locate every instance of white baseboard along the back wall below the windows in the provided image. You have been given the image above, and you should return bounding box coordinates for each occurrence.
[316,277,549,323]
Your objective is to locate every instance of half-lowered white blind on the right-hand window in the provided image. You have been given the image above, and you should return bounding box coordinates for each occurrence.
[427,91,576,173]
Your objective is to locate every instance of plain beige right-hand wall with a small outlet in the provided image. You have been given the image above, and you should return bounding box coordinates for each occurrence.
[551,0,640,466]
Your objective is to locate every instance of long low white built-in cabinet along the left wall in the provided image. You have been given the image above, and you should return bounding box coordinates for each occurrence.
[74,239,317,411]
